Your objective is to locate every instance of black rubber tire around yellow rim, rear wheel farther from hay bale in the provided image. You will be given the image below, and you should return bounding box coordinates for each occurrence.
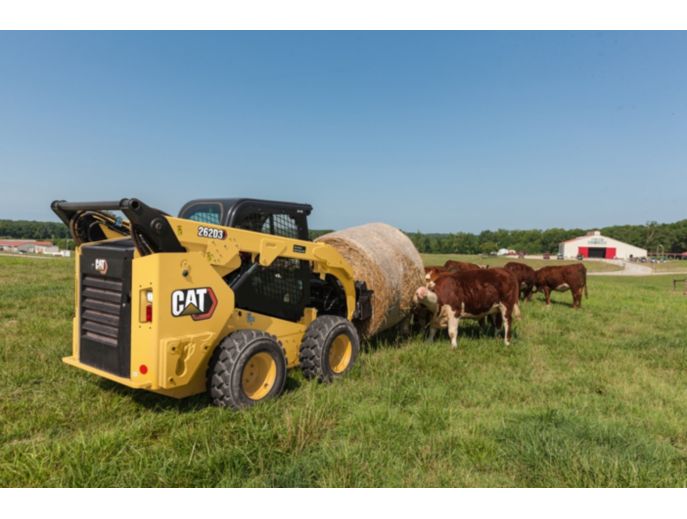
[207,330,286,409]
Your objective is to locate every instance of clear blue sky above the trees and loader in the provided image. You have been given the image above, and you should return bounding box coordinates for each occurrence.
[0,32,687,232]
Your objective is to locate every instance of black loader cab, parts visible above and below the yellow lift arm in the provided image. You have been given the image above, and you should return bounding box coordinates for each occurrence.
[179,198,312,321]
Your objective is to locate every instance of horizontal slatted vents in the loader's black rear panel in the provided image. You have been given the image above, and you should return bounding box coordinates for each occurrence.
[81,274,122,346]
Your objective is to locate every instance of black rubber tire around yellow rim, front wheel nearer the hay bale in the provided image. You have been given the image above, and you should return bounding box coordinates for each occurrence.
[299,315,360,382]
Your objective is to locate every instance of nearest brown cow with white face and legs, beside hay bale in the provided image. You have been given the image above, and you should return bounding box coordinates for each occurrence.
[413,268,520,348]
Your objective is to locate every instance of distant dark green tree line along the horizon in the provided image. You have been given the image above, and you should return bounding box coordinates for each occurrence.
[0,220,687,254]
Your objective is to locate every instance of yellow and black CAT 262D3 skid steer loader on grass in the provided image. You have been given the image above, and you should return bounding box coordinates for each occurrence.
[51,198,372,408]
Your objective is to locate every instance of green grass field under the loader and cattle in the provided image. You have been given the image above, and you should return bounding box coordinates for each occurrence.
[0,257,687,487]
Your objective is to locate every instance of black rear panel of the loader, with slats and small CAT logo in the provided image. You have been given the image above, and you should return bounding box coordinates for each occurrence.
[79,240,133,377]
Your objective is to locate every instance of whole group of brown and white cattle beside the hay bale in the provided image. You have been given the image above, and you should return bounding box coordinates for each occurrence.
[413,260,587,348]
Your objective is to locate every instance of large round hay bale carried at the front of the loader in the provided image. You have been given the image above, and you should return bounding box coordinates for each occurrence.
[315,223,424,338]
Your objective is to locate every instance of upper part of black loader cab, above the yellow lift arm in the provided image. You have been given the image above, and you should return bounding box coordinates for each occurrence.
[179,198,312,240]
